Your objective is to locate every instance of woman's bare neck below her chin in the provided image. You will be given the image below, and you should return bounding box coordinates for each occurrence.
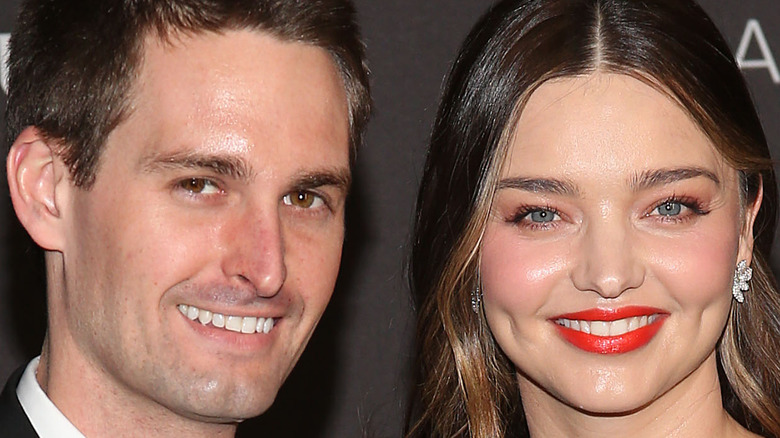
[518,354,755,438]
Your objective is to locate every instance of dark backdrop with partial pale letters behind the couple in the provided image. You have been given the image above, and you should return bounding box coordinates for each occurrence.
[0,0,780,438]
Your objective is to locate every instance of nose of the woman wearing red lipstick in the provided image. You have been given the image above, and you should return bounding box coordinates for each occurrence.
[571,219,645,298]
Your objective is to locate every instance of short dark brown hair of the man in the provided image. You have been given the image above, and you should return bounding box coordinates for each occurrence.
[6,0,370,188]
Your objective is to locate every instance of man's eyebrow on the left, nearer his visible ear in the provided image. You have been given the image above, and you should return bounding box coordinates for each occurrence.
[141,152,255,180]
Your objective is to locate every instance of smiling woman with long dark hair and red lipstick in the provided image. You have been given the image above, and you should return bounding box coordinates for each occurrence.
[408,0,780,438]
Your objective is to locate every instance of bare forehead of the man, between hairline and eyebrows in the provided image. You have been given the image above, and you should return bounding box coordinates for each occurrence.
[102,26,349,177]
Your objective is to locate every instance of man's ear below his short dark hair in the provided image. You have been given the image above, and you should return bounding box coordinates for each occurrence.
[6,127,70,251]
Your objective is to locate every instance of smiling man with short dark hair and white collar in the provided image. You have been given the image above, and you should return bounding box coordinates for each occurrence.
[0,0,369,437]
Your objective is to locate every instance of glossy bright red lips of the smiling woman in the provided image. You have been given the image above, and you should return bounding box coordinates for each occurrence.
[550,306,669,354]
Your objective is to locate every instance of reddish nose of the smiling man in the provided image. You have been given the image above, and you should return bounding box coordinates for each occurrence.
[223,209,287,297]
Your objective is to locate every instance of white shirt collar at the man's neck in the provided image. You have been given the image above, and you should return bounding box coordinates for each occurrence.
[16,356,84,438]
